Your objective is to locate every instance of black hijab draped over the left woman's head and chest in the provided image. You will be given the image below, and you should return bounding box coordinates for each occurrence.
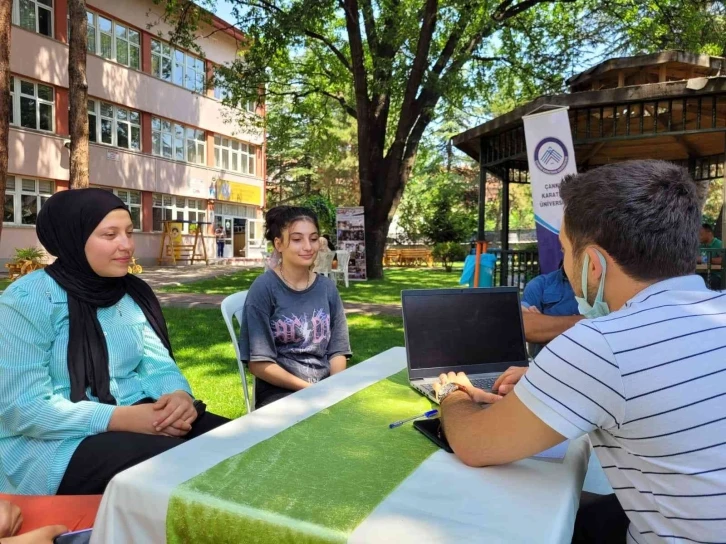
[36,189,173,404]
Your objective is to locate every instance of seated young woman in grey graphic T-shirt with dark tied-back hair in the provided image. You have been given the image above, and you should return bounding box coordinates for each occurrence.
[239,206,351,408]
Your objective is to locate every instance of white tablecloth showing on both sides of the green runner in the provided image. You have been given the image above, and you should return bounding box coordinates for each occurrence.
[91,348,590,544]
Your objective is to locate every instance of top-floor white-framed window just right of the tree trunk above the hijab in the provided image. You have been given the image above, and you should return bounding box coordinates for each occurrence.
[86,11,141,70]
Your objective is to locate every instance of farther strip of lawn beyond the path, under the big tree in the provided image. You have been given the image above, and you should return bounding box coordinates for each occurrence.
[163,264,462,304]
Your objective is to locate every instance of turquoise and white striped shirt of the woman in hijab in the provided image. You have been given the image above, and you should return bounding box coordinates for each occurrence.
[0,270,191,495]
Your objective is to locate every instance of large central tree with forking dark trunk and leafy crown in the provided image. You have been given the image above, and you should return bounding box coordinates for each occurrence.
[205,0,582,277]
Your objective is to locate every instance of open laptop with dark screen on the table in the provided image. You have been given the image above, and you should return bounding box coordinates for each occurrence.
[401,287,528,402]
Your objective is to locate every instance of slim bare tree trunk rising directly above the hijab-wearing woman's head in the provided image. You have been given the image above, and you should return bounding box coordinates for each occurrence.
[68,0,89,189]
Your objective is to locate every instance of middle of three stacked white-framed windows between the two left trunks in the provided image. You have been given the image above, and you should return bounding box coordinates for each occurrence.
[10,77,55,132]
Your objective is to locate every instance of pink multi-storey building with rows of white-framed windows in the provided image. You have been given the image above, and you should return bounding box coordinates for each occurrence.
[0,0,266,264]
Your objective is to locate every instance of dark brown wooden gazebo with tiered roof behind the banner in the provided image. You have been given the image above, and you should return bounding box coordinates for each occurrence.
[453,51,726,284]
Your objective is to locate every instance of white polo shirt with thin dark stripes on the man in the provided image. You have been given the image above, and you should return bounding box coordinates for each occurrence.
[515,276,726,544]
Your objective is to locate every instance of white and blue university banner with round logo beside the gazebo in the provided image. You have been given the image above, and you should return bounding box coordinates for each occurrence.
[522,108,577,274]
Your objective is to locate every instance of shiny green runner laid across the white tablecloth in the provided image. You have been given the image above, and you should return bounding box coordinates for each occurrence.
[166,370,436,544]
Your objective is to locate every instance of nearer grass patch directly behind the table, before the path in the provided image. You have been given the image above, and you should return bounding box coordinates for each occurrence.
[164,308,403,418]
